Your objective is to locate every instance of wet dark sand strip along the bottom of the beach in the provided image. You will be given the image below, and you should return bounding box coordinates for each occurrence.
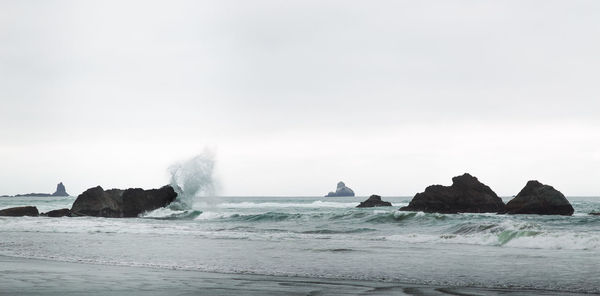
[0,256,592,296]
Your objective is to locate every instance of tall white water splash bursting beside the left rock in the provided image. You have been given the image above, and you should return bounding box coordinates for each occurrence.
[169,151,216,210]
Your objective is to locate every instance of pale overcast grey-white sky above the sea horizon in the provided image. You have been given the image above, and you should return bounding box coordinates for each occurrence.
[0,0,600,196]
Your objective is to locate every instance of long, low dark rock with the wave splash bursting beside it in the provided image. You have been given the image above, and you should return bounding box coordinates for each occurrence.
[71,185,177,218]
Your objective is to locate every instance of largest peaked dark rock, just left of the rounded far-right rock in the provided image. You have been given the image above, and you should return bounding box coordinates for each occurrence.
[400,174,504,214]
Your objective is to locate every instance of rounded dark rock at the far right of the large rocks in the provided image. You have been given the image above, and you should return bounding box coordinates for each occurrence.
[501,181,575,216]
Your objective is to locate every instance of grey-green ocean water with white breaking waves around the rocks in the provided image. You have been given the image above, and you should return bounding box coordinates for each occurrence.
[0,196,600,295]
